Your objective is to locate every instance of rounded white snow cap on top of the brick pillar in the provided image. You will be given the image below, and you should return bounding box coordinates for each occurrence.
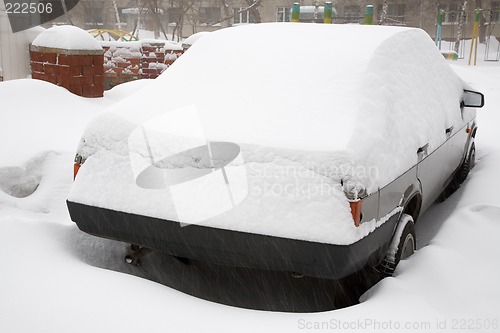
[32,25,102,51]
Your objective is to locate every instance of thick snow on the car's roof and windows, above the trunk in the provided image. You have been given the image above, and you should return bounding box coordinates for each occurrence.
[93,23,462,191]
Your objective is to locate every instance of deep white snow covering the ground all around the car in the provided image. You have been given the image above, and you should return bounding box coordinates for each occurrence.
[0,50,500,333]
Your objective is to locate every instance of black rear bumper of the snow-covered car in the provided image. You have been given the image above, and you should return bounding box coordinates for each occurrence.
[67,201,397,279]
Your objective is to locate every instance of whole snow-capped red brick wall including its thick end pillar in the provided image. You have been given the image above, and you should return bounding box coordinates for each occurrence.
[30,26,183,92]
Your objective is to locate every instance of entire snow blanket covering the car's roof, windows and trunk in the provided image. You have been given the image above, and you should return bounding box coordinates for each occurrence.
[70,24,466,244]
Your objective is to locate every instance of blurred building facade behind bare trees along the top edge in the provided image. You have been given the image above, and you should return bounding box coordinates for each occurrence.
[44,0,500,40]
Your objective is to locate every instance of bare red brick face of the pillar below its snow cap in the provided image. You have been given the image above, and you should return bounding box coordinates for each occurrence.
[30,45,104,97]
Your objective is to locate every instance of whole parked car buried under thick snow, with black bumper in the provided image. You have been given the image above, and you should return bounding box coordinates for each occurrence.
[67,23,484,279]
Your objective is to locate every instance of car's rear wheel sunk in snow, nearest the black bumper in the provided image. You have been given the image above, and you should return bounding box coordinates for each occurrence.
[379,214,417,277]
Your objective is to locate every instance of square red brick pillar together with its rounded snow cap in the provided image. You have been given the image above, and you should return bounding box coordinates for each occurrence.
[30,27,104,97]
